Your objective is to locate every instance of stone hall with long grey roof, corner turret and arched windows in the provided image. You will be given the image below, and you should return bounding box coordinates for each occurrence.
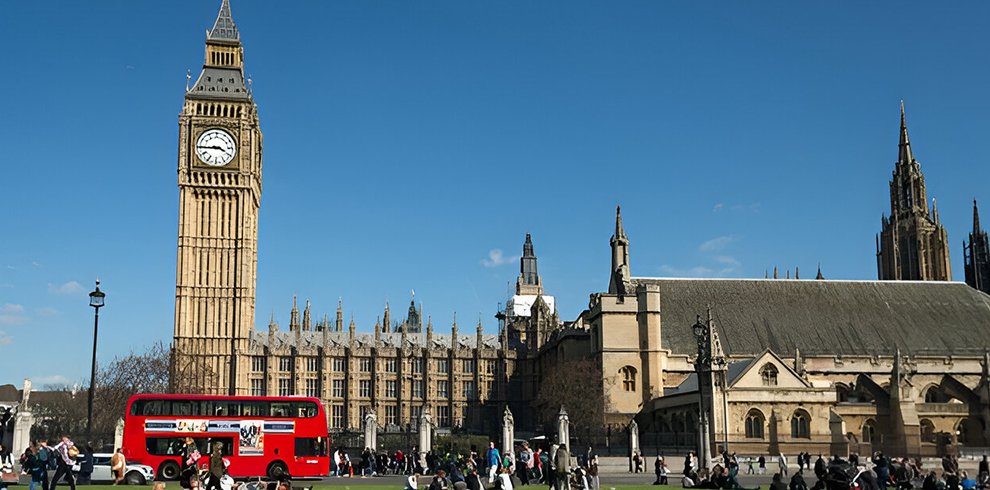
[560,209,990,455]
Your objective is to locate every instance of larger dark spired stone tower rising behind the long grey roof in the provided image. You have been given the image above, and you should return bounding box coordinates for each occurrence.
[877,102,952,281]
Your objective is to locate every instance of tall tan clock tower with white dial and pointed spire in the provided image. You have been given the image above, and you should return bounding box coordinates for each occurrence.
[171,0,262,394]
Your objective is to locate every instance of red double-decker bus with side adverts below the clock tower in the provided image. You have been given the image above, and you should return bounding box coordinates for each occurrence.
[123,395,330,480]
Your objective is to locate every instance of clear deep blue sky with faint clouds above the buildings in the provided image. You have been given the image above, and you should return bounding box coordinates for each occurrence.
[0,0,990,384]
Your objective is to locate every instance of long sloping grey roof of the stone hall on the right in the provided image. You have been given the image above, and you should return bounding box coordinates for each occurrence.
[631,278,990,357]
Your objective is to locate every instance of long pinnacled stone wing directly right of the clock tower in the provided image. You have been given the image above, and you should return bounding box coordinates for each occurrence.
[244,304,515,431]
